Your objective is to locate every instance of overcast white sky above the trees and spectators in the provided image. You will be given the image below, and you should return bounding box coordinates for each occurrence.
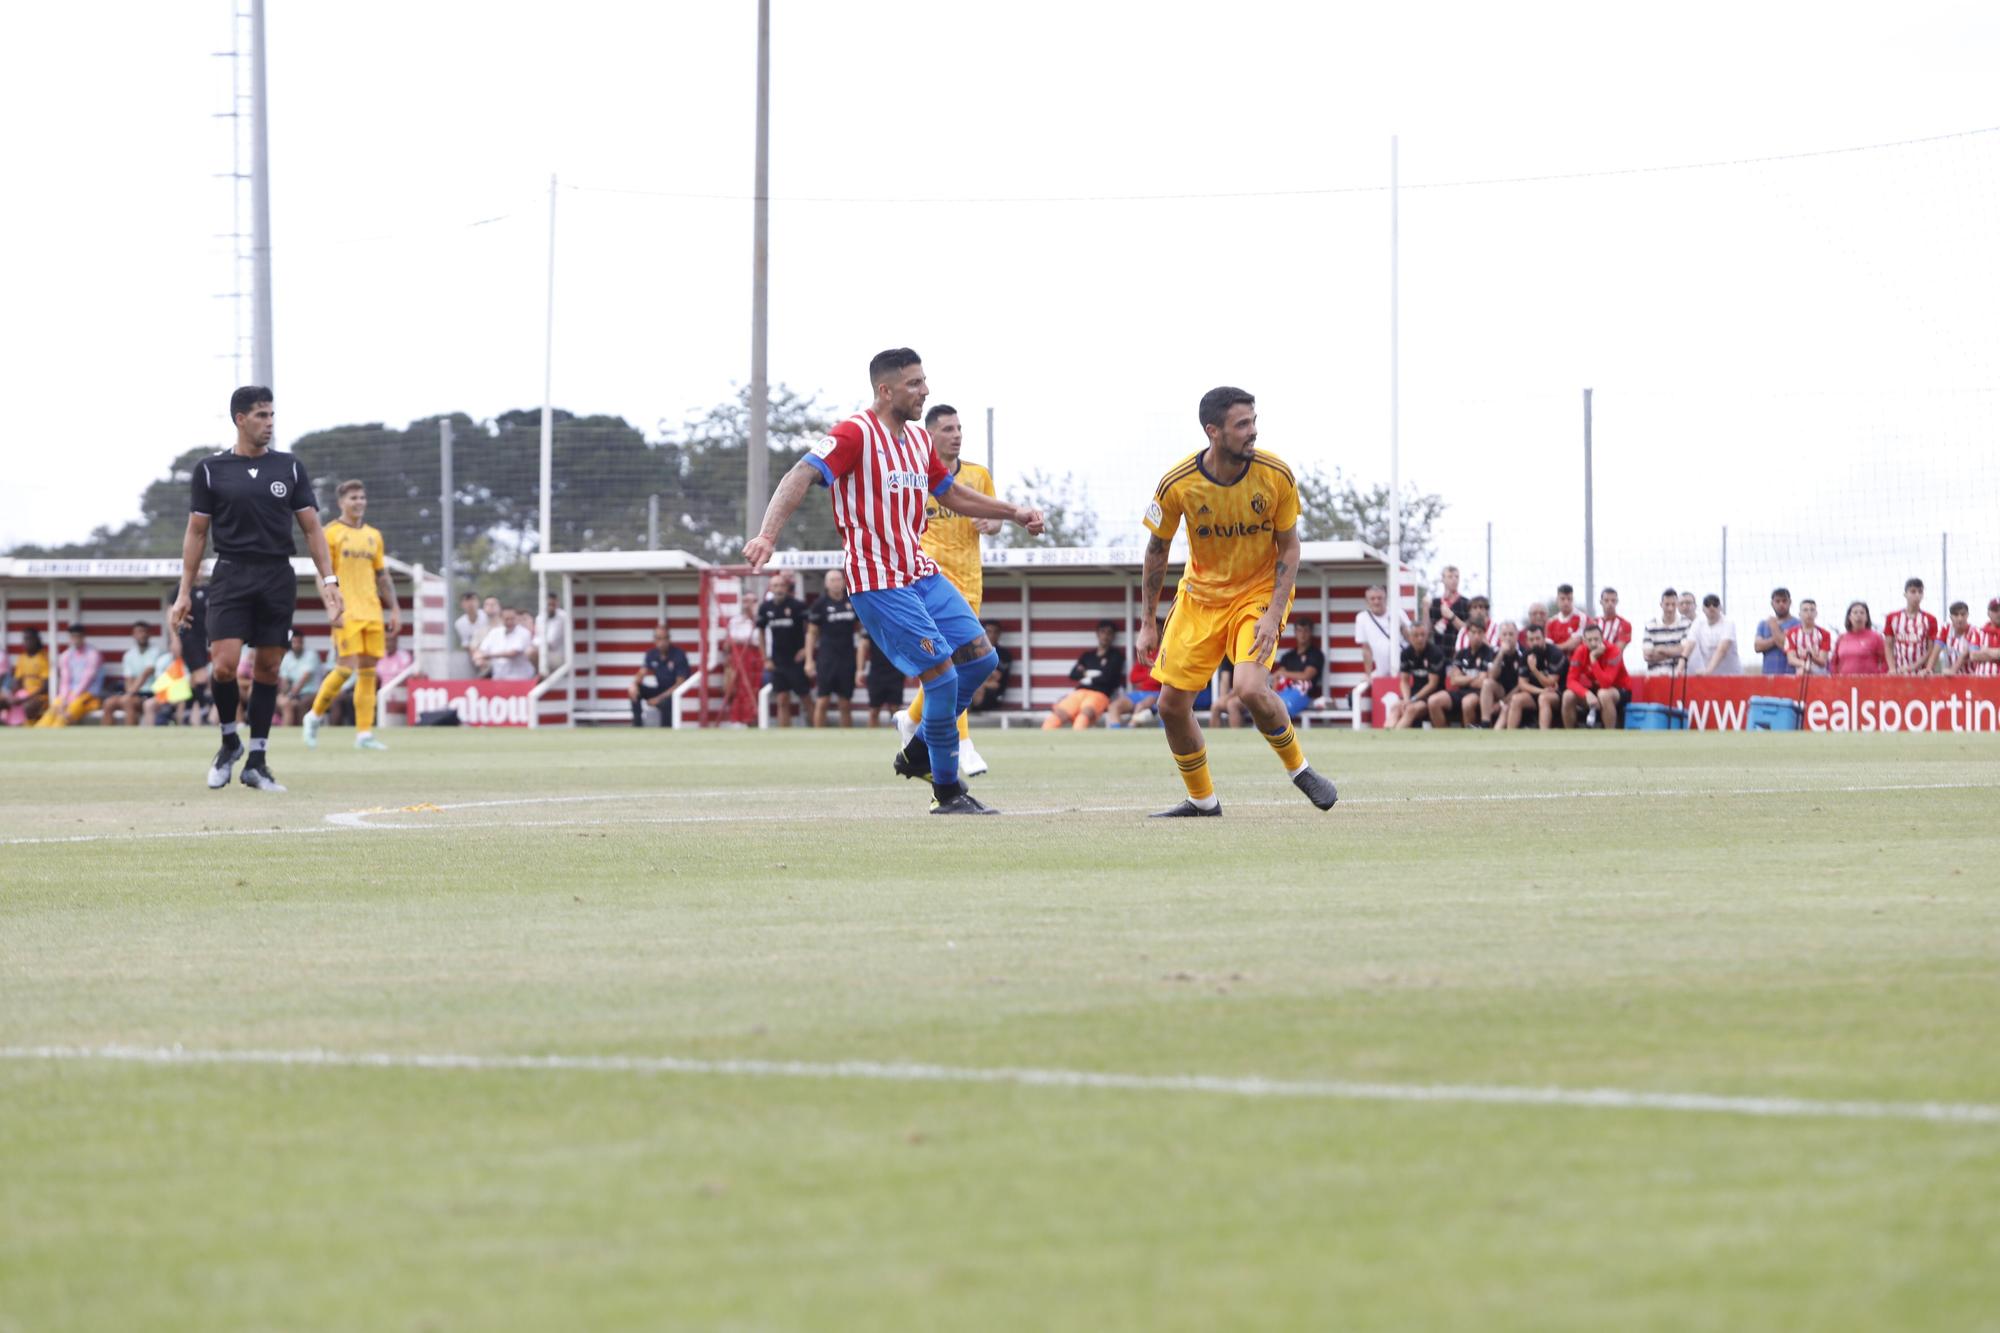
[0,0,2000,616]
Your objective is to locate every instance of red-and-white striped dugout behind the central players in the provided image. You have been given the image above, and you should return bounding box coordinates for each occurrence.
[534,542,1418,727]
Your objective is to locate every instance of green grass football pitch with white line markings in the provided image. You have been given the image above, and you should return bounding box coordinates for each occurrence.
[0,729,2000,1333]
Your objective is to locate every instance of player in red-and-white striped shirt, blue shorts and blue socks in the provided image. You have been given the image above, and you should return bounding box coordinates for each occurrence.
[744,346,1042,815]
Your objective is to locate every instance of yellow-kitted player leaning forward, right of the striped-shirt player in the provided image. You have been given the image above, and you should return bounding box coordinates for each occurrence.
[1138,388,1338,819]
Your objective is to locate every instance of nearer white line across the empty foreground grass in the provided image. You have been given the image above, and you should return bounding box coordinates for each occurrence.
[0,1047,2000,1125]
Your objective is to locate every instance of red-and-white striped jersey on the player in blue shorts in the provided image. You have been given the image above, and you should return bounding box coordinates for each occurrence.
[806,410,952,592]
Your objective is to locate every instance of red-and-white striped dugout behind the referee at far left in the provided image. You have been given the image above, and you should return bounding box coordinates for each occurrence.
[0,556,448,723]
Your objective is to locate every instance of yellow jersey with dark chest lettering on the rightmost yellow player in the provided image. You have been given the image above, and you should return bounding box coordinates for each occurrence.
[1146,448,1298,606]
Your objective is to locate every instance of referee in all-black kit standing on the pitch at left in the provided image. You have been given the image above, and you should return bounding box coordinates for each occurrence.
[168,384,340,791]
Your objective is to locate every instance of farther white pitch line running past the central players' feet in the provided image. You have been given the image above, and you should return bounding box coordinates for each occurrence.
[0,783,2000,847]
